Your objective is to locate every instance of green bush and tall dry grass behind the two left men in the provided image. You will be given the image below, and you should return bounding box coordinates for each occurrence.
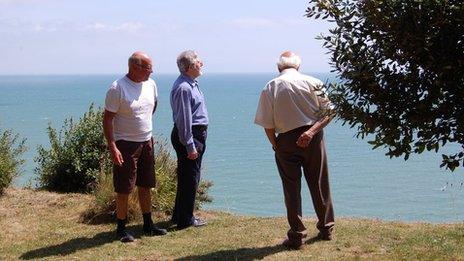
[36,102,212,222]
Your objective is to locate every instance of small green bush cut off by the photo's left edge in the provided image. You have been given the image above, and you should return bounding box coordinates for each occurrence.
[0,127,26,195]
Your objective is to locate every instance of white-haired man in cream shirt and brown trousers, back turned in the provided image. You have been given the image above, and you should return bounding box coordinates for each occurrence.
[255,51,334,249]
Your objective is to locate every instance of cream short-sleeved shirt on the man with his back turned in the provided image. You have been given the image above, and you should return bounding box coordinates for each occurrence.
[255,69,332,133]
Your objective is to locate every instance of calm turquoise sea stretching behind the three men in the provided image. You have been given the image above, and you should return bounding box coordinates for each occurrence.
[0,73,464,223]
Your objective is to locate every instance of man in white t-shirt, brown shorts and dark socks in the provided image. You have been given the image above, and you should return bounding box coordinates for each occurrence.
[103,52,167,242]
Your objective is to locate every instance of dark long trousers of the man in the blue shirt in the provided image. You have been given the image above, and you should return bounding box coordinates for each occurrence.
[171,125,207,225]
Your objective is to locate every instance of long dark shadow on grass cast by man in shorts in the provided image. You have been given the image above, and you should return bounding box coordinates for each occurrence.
[19,225,142,260]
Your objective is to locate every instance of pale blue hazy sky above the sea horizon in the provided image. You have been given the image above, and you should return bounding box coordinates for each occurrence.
[0,0,331,75]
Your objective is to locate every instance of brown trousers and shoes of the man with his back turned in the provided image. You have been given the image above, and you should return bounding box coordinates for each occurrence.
[275,126,334,244]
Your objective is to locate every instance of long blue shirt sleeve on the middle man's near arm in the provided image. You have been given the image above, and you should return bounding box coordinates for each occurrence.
[172,87,196,153]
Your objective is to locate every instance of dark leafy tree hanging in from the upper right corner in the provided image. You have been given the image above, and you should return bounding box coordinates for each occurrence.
[306,0,464,171]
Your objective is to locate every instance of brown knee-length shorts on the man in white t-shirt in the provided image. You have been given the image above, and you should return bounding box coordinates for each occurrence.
[113,139,156,194]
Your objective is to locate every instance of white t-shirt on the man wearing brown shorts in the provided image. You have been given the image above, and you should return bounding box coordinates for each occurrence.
[105,76,158,142]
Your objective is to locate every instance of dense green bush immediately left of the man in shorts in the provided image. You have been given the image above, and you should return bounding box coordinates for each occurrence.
[35,104,110,192]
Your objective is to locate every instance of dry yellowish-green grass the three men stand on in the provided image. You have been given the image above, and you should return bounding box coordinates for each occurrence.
[0,188,464,260]
